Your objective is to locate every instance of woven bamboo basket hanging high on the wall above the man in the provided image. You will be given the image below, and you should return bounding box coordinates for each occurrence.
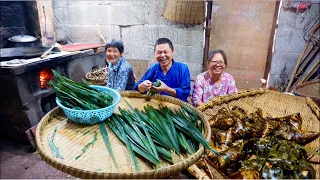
[163,0,205,24]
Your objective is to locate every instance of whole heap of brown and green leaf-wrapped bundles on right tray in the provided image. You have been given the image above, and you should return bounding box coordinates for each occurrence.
[196,106,320,179]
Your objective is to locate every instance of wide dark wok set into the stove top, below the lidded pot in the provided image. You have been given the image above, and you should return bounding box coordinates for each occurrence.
[0,47,61,61]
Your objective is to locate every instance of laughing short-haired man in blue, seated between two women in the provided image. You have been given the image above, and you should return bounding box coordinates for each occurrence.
[134,38,190,102]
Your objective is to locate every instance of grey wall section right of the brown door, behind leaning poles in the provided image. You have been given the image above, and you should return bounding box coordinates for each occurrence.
[269,1,320,90]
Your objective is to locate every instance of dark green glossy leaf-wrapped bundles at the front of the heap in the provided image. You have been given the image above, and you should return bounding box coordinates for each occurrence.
[229,138,315,179]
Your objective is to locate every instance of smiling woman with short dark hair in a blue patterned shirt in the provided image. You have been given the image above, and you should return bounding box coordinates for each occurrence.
[106,40,135,90]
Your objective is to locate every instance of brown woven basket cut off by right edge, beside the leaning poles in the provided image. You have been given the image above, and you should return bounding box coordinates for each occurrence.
[293,79,320,105]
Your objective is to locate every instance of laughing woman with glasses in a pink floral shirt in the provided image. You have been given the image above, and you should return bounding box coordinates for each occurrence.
[192,50,237,106]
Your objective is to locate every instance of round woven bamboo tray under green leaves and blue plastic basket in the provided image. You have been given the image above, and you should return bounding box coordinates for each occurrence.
[36,91,211,179]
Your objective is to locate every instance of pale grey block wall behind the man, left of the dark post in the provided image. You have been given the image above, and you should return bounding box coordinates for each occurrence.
[53,0,203,76]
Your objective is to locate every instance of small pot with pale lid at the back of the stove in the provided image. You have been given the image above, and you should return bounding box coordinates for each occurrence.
[8,35,37,47]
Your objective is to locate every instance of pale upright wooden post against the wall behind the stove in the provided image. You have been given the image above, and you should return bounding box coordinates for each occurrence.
[36,0,56,46]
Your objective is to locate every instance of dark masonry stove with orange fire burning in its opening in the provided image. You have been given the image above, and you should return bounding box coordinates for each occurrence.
[0,49,106,141]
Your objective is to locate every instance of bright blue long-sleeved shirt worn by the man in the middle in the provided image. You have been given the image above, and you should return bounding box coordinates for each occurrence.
[134,59,190,102]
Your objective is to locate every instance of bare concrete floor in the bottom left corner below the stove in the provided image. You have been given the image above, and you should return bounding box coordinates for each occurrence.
[0,141,75,179]
